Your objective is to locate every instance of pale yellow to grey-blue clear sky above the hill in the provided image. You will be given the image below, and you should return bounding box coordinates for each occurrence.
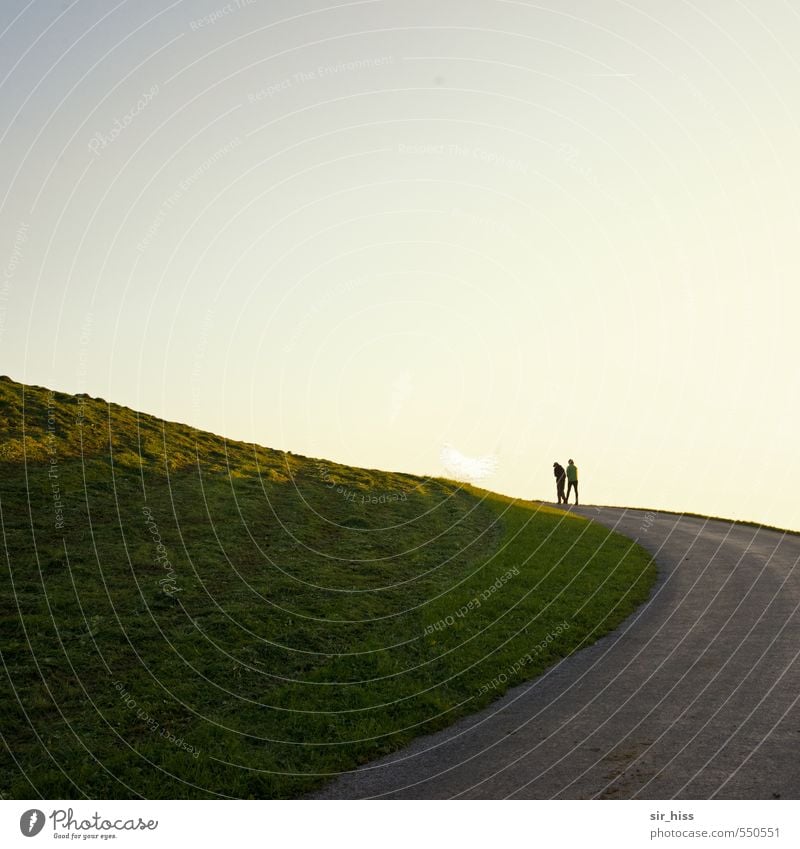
[0,0,800,529]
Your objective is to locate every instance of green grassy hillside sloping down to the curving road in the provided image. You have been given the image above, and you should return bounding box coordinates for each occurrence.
[0,378,655,798]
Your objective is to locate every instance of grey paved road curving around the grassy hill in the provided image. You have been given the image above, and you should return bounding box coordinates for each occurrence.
[318,507,800,799]
